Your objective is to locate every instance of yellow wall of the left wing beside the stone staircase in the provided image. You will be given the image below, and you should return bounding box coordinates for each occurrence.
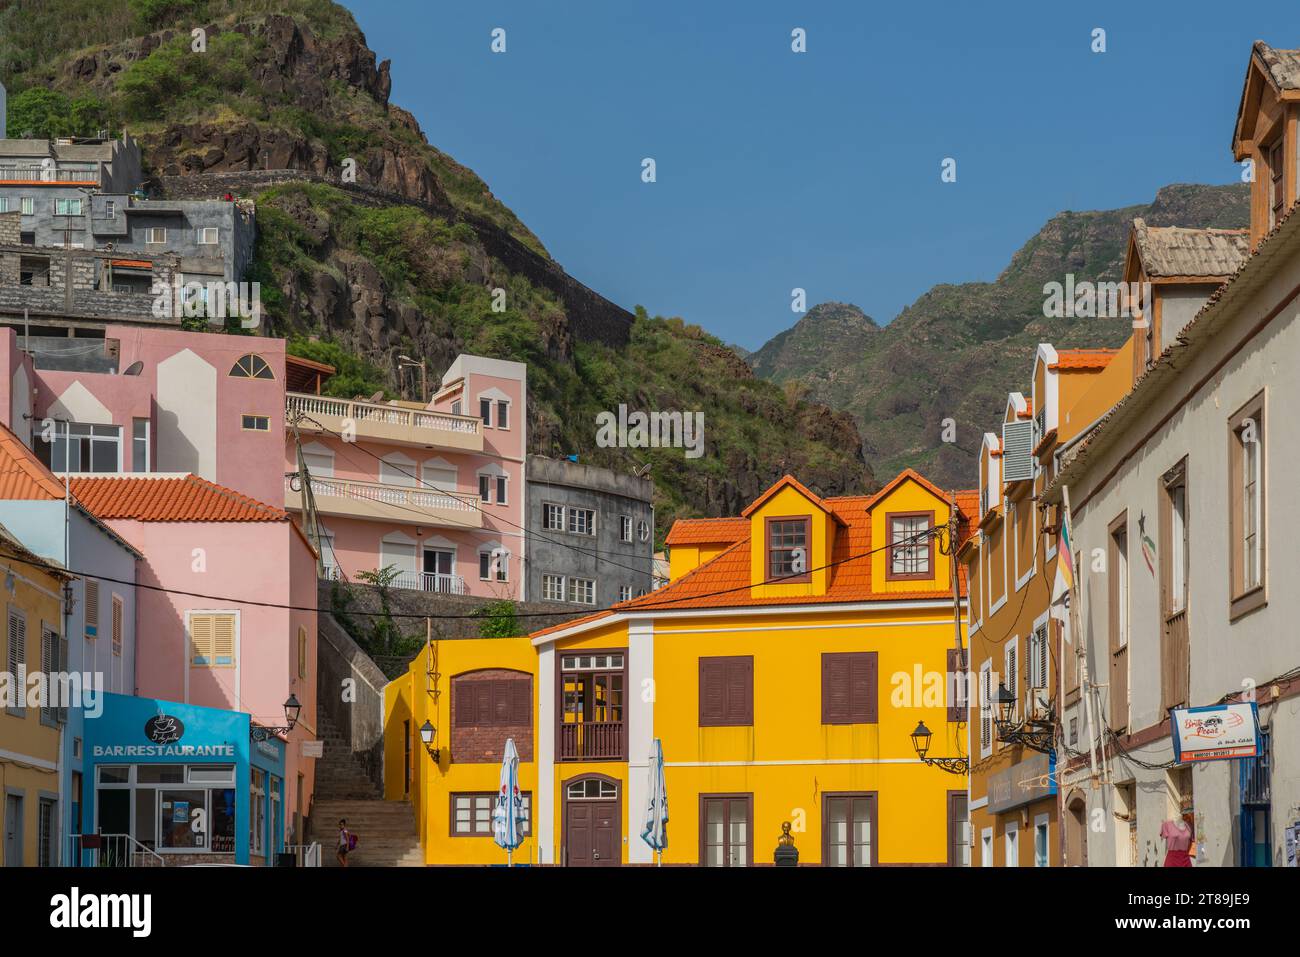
[384,638,537,865]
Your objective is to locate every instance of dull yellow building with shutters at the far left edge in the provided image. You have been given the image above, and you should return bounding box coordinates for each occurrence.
[0,525,69,867]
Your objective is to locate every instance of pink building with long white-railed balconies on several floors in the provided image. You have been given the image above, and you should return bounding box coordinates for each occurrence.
[283,355,528,599]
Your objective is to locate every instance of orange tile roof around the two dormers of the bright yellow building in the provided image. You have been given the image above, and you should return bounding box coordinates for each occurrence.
[532,469,979,638]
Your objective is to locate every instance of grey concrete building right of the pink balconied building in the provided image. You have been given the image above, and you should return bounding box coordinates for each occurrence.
[525,455,654,607]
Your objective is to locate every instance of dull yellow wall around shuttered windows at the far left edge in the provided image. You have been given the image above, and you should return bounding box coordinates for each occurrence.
[0,549,62,867]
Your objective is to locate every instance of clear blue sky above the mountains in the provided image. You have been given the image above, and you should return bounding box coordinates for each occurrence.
[345,0,1300,348]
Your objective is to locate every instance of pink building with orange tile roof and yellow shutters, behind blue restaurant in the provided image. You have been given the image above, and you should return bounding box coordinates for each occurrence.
[72,475,319,843]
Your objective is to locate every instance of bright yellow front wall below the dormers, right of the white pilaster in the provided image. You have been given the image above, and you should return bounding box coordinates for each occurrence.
[654,611,966,863]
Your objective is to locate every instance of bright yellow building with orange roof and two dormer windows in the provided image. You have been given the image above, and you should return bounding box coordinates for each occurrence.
[386,471,974,866]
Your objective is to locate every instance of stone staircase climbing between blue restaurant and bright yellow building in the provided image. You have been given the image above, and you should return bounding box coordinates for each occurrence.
[312,710,424,867]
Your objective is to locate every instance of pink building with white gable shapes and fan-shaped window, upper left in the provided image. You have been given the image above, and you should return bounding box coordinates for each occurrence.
[0,325,285,502]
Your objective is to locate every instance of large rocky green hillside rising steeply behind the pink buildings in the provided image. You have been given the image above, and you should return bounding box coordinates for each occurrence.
[0,0,874,536]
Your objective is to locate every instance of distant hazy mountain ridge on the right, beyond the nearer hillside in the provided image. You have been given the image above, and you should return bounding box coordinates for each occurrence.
[748,185,1249,486]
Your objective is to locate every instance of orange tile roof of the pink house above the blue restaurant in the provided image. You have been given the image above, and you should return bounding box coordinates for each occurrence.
[72,473,289,521]
